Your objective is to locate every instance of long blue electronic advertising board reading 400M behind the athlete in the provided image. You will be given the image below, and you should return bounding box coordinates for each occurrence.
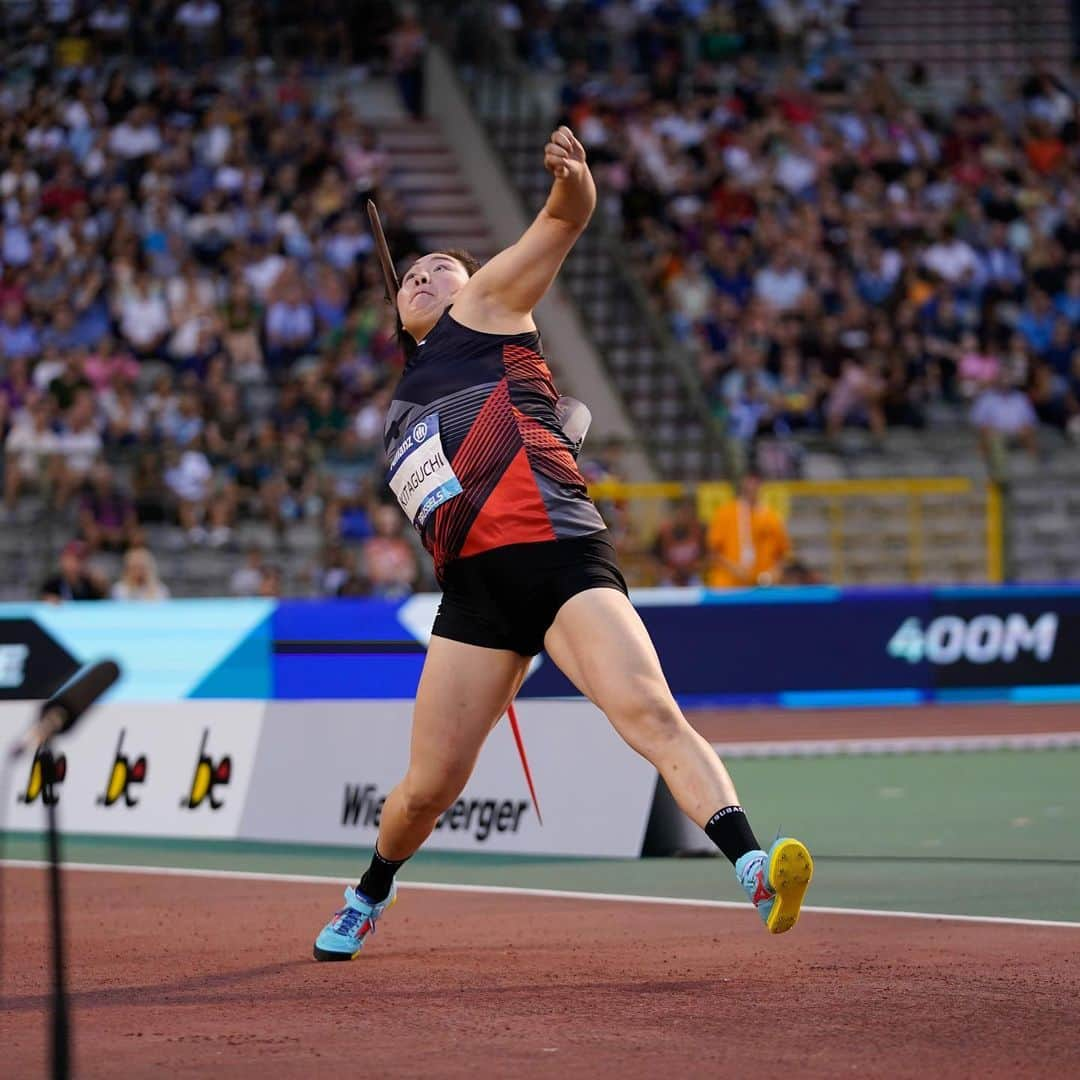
[0,586,1080,707]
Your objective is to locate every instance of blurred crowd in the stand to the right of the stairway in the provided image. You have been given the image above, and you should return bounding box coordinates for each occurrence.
[479,0,1080,464]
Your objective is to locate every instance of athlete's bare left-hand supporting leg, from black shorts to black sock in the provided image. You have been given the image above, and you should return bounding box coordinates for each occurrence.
[378,637,529,862]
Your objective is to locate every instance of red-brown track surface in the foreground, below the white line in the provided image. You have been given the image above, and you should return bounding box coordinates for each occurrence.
[0,870,1080,1080]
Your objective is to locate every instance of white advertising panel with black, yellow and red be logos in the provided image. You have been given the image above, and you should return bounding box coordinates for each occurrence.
[0,701,266,837]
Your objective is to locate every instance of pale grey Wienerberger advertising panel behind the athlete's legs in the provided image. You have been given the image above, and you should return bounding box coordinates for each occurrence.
[240,701,657,858]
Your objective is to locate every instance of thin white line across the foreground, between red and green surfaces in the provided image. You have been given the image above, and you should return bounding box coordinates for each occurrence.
[0,859,1080,930]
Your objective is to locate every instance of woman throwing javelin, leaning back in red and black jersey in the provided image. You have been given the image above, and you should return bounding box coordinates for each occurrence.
[314,127,813,960]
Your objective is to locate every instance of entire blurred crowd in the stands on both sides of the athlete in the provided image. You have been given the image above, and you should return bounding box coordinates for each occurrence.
[0,0,1080,595]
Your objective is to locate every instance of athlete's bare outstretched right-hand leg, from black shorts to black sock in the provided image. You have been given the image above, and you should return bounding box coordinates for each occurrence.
[544,589,739,827]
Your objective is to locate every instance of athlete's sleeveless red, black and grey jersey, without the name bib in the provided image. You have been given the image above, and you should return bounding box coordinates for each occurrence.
[384,309,604,575]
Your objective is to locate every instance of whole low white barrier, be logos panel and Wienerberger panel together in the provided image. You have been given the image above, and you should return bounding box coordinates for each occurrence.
[0,700,657,858]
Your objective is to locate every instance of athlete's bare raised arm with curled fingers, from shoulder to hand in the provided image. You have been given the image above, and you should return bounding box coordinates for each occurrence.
[454,126,596,334]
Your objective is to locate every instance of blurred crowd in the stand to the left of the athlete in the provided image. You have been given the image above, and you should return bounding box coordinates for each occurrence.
[0,0,429,595]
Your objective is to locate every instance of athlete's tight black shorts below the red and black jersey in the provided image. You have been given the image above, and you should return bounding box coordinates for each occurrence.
[431,529,626,657]
